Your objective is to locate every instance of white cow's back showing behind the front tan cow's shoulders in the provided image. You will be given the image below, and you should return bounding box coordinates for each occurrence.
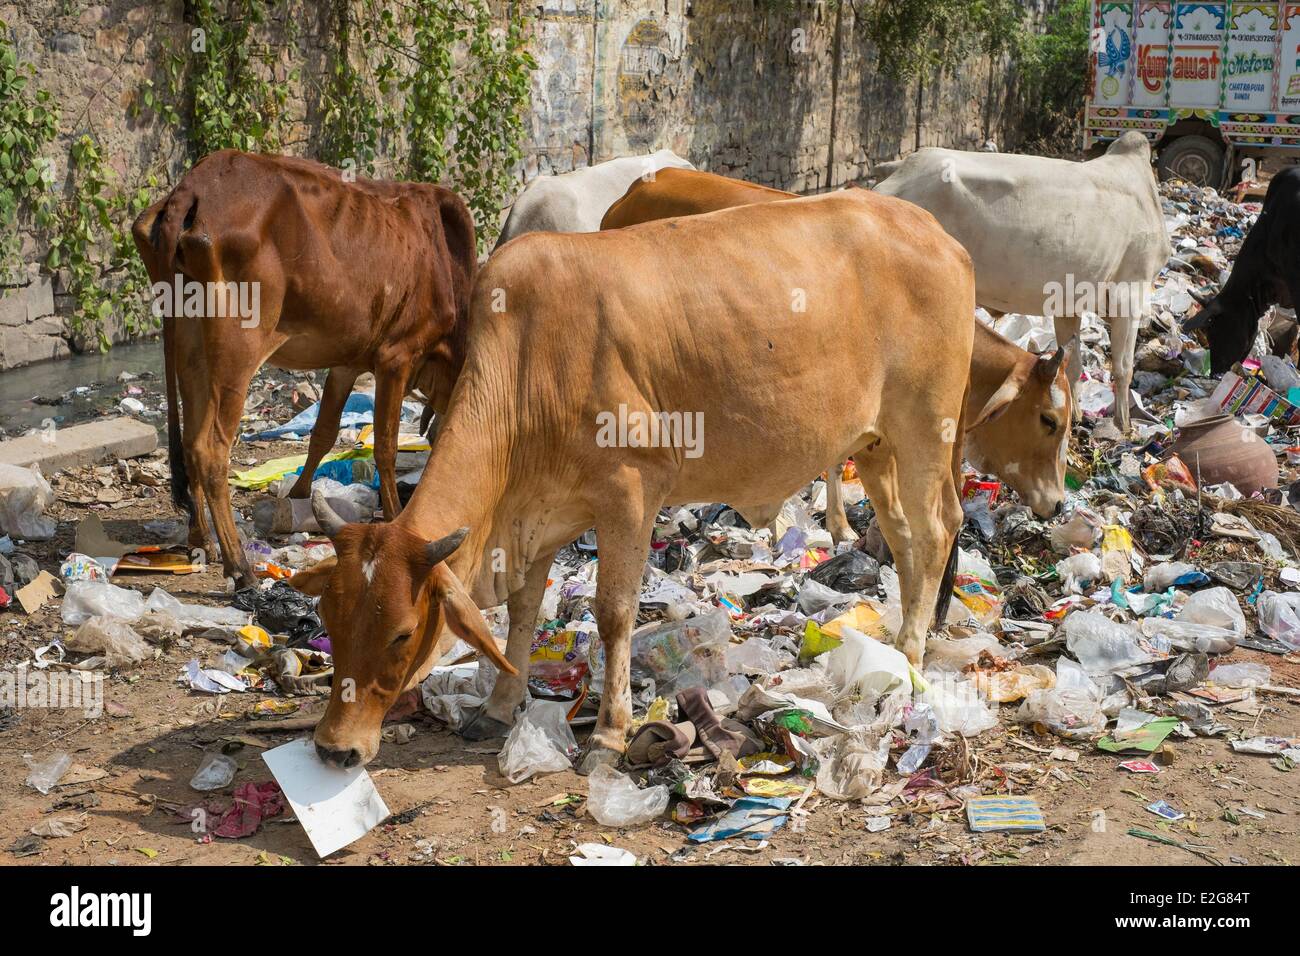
[493,150,694,251]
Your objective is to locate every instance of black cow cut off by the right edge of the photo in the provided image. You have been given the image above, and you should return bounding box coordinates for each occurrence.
[1183,166,1300,375]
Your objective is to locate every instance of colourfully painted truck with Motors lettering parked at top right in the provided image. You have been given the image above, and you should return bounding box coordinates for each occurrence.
[1084,0,1300,187]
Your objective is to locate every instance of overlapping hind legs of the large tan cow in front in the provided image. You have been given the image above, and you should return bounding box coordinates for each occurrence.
[859,449,962,670]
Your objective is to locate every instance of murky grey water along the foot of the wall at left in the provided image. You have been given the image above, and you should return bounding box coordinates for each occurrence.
[0,339,166,437]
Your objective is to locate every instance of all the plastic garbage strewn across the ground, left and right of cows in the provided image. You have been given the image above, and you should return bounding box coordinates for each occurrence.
[0,175,1300,865]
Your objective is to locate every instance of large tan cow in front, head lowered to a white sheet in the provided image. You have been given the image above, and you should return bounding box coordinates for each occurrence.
[293,191,975,769]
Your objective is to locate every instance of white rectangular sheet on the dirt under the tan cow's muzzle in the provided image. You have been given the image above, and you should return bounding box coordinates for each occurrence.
[261,737,389,858]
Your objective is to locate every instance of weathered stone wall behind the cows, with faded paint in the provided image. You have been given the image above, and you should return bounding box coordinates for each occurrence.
[0,0,1034,368]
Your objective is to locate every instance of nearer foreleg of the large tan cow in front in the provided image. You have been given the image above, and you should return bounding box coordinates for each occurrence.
[579,481,663,774]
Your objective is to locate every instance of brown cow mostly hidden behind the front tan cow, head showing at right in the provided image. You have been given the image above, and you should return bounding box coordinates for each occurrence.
[601,169,1073,541]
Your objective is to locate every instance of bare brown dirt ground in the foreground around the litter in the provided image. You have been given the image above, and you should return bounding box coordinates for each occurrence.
[0,445,1300,866]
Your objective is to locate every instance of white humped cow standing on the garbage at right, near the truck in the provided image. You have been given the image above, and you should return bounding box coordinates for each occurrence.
[876,133,1169,432]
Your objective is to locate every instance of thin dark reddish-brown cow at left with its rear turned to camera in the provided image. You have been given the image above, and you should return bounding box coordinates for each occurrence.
[133,150,476,584]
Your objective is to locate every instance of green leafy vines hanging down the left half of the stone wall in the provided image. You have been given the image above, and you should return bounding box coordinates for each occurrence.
[0,0,536,349]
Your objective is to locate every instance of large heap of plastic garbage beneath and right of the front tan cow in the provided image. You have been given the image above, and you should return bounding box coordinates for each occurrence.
[424,175,1300,843]
